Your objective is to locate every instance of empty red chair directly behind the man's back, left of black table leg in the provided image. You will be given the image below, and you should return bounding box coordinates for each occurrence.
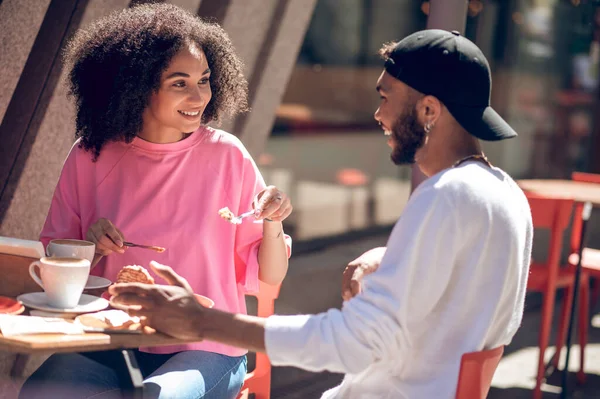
[526,193,574,399]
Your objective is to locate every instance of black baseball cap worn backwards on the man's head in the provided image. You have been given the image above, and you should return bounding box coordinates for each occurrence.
[385,29,517,141]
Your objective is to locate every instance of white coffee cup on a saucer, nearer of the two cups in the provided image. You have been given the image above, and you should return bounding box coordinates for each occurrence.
[29,257,90,309]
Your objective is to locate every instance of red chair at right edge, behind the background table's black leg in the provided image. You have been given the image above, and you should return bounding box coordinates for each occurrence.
[553,172,600,383]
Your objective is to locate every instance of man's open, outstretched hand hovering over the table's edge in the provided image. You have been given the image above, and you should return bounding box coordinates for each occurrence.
[109,261,204,340]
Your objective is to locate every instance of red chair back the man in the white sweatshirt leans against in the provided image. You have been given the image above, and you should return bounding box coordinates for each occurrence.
[456,346,504,399]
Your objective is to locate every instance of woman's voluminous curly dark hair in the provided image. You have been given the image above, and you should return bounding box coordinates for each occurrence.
[65,4,248,160]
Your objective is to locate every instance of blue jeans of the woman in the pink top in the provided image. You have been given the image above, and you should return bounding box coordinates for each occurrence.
[19,350,246,399]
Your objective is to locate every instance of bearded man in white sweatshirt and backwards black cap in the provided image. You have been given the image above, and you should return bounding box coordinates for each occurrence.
[111,30,533,398]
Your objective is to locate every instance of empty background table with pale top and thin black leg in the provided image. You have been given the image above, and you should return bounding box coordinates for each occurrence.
[517,179,600,398]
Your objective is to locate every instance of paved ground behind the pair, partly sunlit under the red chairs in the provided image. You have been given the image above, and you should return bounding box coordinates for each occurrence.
[264,235,600,399]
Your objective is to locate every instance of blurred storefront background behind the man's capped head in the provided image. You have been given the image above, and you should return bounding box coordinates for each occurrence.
[258,0,600,250]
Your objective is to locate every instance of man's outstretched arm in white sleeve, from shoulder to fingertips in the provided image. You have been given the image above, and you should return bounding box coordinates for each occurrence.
[110,190,459,373]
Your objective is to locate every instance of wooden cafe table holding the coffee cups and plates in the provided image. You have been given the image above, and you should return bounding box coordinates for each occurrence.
[0,322,202,398]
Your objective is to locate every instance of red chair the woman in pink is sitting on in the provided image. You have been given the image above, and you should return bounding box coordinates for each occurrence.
[238,282,281,399]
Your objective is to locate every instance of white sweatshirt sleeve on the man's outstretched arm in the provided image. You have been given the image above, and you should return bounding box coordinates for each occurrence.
[265,187,458,374]
